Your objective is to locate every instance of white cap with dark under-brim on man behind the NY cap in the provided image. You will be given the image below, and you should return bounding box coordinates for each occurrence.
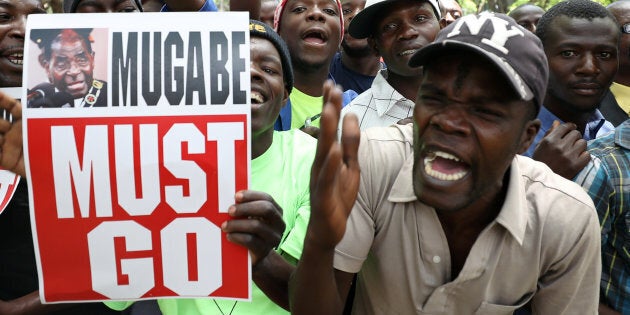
[348,0,440,38]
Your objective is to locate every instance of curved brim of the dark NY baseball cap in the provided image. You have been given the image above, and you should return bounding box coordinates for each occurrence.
[409,40,534,101]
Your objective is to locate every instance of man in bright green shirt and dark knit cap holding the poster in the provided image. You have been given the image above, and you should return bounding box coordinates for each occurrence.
[106,20,316,315]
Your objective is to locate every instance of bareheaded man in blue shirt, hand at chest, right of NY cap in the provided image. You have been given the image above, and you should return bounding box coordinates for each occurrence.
[525,0,620,179]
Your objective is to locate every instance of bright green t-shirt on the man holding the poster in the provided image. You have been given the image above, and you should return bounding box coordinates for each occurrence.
[105,130,317,315]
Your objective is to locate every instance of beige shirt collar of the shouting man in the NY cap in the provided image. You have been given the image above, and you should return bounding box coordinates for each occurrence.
[387,153,528,245]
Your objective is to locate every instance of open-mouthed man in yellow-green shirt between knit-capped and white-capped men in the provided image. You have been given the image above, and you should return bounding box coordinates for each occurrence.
[274,0,357,138]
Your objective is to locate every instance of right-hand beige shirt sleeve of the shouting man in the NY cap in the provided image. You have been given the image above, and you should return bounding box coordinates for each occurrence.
[532,199,602,314]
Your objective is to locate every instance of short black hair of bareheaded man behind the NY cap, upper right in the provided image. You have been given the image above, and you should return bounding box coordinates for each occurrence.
[536,0,617,46]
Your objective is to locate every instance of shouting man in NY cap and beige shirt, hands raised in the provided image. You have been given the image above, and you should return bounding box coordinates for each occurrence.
[290,13,601,314]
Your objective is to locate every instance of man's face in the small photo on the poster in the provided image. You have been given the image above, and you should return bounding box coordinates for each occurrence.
[40,29,94,98]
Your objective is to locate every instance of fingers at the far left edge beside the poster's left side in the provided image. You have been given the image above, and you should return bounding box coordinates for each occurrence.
[0,92,25,176]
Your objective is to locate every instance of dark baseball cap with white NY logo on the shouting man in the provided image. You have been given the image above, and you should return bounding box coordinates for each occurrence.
[409,12,549,109]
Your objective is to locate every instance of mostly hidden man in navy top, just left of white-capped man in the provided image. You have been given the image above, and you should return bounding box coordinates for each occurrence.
[330,0,385,94]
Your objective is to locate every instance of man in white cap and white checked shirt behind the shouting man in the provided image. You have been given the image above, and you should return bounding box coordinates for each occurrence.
[341,0,440,130]
